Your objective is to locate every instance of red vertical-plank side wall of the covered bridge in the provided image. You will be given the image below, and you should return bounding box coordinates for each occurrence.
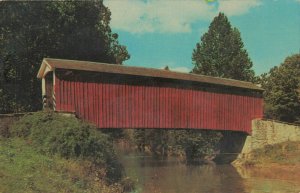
[55,78,263,133]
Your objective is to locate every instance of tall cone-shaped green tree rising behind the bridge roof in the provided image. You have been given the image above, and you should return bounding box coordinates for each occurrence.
[192,13,254,81]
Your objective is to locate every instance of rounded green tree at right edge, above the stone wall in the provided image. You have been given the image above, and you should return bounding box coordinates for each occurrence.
[261,54,300,123]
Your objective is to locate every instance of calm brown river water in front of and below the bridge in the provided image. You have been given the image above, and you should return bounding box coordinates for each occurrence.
[118,149,300,193]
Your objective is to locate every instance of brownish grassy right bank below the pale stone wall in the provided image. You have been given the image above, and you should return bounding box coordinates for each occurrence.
[233,142,300,182]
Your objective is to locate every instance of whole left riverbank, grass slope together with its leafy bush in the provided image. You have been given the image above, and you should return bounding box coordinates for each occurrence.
[0,112,133,192]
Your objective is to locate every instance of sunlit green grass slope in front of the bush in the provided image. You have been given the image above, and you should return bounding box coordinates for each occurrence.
[0,138,108,193]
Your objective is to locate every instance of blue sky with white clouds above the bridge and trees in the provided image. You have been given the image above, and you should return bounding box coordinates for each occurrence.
[104,0,300,75]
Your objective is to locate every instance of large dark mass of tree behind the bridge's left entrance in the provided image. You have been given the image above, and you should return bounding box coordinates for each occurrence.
[0,0,129,113]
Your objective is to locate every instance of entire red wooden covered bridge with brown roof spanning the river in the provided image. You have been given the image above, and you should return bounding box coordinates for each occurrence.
[38,58,263,133]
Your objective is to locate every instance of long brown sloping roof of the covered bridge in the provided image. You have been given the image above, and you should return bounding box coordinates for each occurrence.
[37,58,263,91]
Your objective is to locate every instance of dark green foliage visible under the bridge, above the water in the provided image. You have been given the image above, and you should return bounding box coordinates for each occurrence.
[133,129,222,164]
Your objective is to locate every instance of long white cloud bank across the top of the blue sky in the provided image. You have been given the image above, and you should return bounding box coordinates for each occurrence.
[104,0,260,33]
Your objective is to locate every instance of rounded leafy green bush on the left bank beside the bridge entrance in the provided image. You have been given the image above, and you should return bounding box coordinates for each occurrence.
[11,111,123,183]
